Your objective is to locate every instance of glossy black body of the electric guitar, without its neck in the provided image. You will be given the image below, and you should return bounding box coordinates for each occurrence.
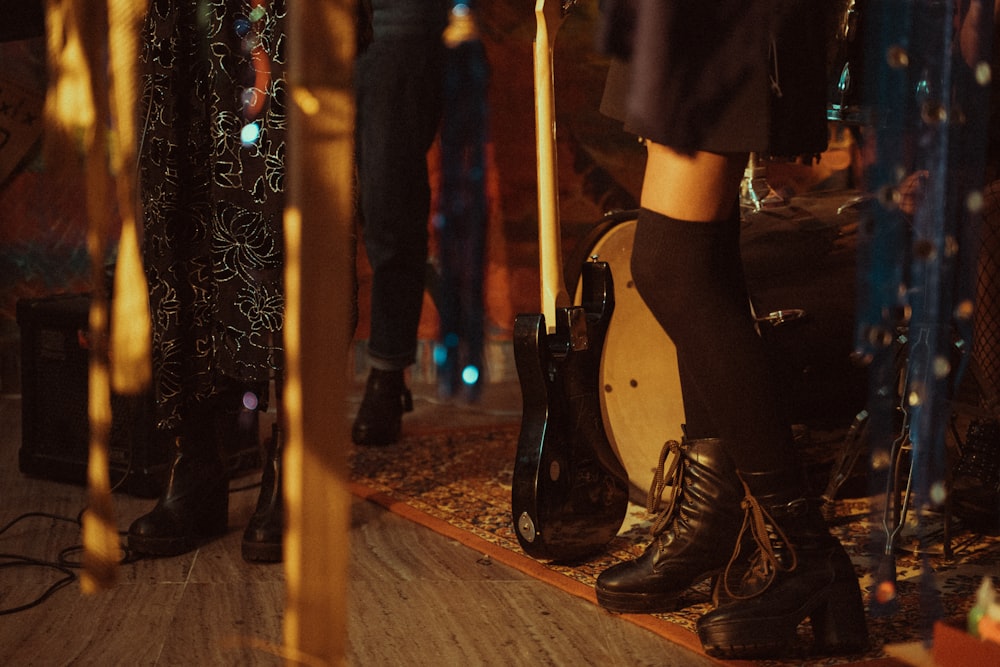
[511,262,629,561]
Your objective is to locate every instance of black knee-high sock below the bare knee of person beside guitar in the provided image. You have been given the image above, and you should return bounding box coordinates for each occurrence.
[632,209,797,472]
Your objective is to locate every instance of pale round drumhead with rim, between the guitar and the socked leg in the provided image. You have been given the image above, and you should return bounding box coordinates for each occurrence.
[565,211,684,505]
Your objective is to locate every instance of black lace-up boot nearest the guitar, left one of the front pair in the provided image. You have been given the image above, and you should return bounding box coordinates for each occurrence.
[596,438,743,613]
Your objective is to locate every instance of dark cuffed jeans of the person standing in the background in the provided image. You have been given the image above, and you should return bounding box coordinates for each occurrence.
[355,34,444,370]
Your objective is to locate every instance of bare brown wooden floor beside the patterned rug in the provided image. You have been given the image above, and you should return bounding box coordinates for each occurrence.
[0,383,716,667]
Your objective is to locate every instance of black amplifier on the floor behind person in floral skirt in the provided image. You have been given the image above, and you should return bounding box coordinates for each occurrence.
[17,294,260,498]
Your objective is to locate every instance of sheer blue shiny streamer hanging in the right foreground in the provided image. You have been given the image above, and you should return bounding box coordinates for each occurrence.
[857,0,993,632]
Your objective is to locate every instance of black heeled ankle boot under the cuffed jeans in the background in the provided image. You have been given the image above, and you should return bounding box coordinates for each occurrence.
[351,368,413,445]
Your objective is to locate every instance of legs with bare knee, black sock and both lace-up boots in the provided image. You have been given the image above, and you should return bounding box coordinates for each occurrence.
[598,146,867,658]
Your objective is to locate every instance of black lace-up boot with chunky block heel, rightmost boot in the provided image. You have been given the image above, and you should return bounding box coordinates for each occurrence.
[698,471,868,659]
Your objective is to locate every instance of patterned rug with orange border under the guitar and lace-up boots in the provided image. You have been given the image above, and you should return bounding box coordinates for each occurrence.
[352,426,1000,666]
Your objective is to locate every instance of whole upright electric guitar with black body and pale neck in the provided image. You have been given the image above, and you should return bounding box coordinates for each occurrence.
[511,0,628,561]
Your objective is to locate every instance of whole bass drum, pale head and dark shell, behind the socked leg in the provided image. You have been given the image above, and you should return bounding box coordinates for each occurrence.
[565,198,868,504]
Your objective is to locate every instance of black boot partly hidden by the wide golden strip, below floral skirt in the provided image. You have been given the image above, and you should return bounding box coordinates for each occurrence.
[242,424,285,563]
